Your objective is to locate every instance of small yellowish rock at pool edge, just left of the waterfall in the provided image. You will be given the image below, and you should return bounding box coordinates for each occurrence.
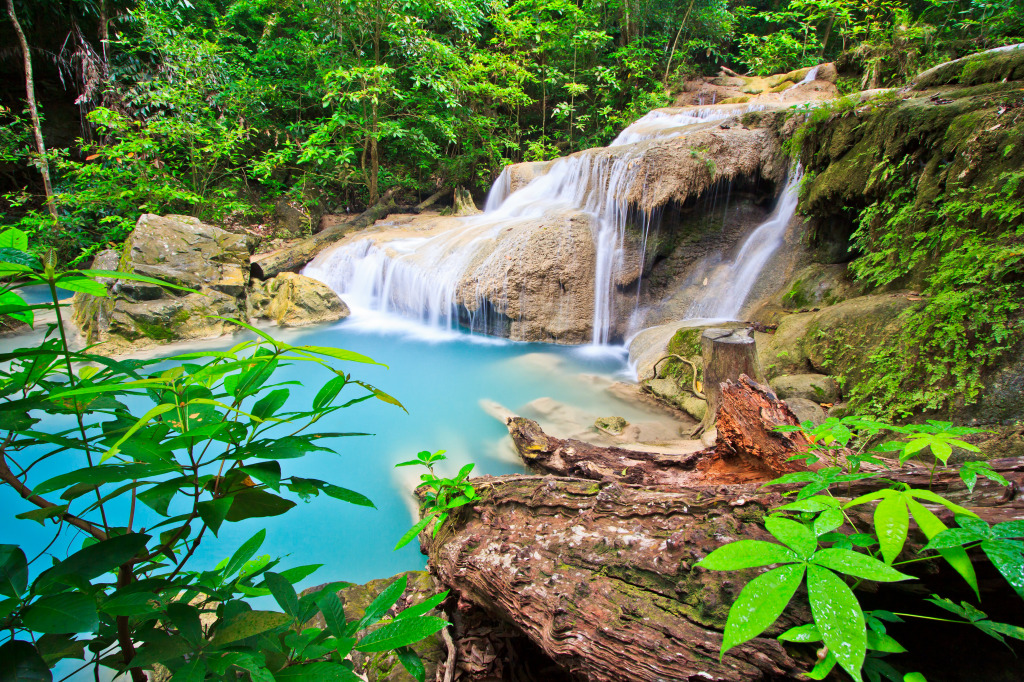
[249,272,349,327]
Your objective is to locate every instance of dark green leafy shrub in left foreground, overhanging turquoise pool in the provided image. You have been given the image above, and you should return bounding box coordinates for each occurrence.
[0,230,447,682]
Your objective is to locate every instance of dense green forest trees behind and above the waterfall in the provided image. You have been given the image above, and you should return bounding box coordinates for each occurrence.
[0,0,1024,261]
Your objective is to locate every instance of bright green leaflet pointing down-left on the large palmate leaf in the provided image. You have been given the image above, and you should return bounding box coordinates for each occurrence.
[719,561,809,659]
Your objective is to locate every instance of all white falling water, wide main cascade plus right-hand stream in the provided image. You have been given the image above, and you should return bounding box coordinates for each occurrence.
[304,105,796,345]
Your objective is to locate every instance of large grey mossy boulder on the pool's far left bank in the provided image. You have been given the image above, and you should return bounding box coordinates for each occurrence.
[73,214,249,345]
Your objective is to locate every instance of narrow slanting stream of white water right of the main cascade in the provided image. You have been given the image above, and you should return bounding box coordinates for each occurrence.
[686,165,804,319]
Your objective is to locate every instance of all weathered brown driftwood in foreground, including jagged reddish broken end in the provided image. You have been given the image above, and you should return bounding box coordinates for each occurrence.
[421,376,1024,682]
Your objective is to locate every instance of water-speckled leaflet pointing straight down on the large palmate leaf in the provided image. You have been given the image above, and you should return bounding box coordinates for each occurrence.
[807,561,864,681]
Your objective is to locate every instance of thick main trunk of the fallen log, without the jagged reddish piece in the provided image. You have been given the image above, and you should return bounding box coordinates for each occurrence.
[424,475,809,682]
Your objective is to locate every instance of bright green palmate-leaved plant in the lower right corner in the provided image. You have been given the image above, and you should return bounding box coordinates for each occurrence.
[697,417,1024,680]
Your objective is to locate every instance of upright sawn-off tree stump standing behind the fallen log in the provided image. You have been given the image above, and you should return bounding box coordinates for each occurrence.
[699,329,767,431]
